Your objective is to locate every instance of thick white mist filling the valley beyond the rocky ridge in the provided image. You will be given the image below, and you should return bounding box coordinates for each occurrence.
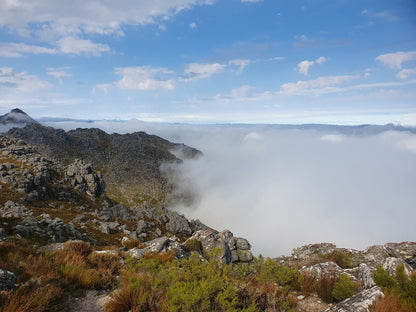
[43,121,416,256]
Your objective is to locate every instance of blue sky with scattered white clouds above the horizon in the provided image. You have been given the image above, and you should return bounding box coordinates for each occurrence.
[0,0,416,125]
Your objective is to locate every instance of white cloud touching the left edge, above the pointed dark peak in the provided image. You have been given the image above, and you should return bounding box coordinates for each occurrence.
[0,67,49,92]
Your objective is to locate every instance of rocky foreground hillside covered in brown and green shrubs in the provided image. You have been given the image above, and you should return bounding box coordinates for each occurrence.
[0,111,416,312]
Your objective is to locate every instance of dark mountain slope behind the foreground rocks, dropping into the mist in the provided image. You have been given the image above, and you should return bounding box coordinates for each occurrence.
[7,109,200,205]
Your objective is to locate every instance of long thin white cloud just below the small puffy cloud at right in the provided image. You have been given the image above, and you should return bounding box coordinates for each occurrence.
[280,75,359,95]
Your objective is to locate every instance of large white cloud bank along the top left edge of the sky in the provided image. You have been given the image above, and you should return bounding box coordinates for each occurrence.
[0,0,214,39]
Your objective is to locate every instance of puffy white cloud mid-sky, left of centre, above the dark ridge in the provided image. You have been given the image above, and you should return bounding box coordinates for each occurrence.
[114,66,175,90]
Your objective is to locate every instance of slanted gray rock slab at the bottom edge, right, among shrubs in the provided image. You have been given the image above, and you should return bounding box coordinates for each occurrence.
[325,286,384,312]
